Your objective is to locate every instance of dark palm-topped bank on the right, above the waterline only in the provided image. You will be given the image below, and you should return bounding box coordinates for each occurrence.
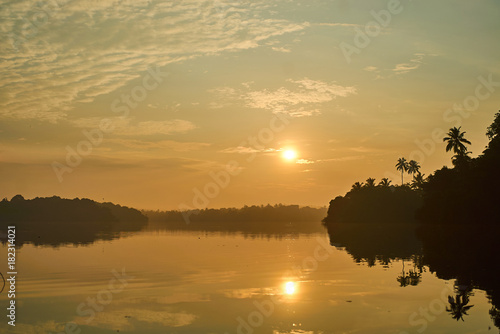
[323,112,500,226]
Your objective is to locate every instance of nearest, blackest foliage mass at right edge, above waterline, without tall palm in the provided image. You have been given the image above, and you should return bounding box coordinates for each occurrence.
[417,113,500,225]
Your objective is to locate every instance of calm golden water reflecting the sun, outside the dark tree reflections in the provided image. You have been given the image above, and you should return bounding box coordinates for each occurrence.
[0,231,498,334]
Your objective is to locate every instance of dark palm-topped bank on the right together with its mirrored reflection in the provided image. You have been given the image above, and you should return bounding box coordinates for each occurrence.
[323,112,500,328]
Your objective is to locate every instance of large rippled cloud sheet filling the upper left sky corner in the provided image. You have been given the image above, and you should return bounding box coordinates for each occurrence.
[0,0,308,122]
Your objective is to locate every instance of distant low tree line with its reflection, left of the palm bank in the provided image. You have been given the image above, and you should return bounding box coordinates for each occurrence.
[0,195,326,247]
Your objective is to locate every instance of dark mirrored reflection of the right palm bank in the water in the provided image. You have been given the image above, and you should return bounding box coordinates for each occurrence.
[325,223,500,328]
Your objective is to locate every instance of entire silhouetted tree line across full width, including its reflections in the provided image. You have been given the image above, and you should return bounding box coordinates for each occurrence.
[0,112,500,328]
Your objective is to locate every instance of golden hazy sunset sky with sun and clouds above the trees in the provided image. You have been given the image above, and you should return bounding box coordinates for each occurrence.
[0,0,500,210]
